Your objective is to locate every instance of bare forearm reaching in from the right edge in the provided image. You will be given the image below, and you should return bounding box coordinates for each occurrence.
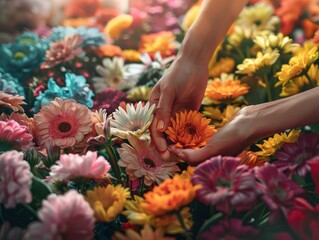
[249,87,319,139]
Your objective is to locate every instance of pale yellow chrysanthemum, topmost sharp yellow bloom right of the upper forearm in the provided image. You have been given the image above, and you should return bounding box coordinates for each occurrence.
[254,31,299,53]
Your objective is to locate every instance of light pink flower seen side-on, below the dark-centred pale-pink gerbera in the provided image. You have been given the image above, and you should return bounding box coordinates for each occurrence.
[50,151,111,181]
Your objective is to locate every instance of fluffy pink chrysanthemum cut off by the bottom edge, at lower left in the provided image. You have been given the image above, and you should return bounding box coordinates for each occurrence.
[24,190,94,240]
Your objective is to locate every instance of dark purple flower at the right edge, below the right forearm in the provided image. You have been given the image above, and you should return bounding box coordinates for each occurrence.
[274,134,319,177]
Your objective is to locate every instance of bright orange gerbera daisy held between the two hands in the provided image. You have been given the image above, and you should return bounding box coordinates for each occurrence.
[165,111,216,149]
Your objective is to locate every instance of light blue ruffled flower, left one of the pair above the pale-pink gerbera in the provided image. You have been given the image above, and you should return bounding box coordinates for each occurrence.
[32,78,69,113]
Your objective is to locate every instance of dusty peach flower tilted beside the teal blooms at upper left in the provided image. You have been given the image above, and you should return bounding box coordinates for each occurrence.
[42,34,83,68]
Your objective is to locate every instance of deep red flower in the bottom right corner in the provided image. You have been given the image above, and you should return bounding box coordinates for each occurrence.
[287,198,319,240]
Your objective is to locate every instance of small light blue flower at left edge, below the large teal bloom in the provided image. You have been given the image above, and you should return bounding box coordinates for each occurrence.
[0,68,25,96]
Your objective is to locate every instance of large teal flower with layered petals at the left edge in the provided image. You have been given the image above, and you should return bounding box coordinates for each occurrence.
[0,33,48,82]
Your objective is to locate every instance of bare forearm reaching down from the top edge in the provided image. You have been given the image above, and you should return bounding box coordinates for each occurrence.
[179,0,248,64]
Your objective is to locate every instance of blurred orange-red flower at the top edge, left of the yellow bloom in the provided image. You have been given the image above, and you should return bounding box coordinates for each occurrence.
[65,0,101,18]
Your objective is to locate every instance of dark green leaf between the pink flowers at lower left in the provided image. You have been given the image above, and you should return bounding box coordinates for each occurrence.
[29,176,52,210]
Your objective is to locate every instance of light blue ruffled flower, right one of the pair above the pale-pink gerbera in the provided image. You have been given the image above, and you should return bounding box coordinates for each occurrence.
[65,73,94,108]
